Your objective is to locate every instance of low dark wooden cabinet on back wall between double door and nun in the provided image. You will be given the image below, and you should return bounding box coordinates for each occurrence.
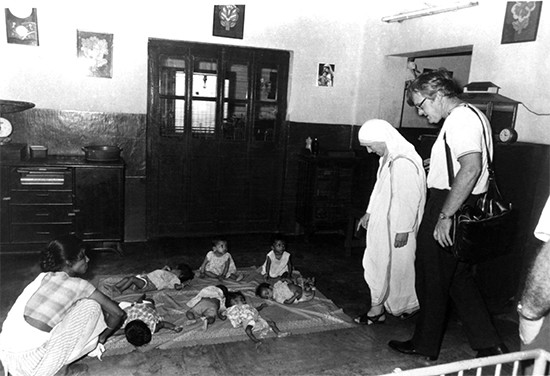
[296,155,359,234]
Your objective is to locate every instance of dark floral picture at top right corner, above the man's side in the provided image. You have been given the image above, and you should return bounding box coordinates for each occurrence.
[501,1,542,44]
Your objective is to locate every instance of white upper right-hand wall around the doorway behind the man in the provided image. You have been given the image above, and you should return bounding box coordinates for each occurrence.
[374,0,550,144]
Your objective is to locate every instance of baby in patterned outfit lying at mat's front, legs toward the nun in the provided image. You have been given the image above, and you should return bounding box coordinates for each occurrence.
[226,291,290,345]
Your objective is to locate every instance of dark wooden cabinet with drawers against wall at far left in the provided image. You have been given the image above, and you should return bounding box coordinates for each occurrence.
[0,156,124,252]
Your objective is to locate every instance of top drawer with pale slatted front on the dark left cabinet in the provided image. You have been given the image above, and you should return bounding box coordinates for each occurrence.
[10,167,73,191]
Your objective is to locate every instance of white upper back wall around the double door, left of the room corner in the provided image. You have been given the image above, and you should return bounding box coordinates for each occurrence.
[0,0,380,124]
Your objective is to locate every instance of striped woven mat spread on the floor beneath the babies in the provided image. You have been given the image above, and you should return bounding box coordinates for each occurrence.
[96,267,354,356]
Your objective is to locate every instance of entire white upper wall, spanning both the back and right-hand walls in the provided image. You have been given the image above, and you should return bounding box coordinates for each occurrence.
[0,0,550,144]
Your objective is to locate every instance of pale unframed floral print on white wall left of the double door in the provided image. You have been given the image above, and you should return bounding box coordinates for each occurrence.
[76,30,113,78]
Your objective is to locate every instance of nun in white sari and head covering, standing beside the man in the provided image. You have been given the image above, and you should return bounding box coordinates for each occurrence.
[355,119,426,325]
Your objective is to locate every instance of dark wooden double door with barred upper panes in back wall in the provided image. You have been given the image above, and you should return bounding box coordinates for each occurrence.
[147,39,289,238]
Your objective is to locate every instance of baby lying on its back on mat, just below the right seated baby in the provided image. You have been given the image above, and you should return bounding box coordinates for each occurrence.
[256,277,315,304]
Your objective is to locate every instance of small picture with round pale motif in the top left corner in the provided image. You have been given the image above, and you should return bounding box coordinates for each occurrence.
[6,7,38,46]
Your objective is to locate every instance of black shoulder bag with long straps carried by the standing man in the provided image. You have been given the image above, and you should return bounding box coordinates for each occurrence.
[443,109,512,264]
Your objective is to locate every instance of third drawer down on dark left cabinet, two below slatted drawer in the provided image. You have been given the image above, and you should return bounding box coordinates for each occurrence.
[11,205,75,223]
